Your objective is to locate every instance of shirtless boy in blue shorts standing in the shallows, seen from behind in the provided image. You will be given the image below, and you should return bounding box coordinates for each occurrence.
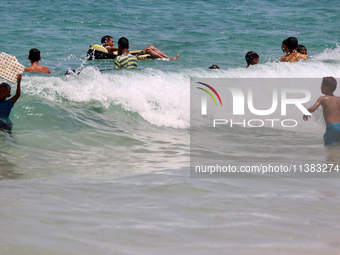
[302,77,340,145]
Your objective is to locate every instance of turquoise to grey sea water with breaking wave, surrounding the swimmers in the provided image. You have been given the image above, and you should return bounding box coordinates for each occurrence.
[0,0,340,255]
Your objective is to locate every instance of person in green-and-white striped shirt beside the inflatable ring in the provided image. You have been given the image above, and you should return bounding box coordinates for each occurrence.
[115,37,137,69]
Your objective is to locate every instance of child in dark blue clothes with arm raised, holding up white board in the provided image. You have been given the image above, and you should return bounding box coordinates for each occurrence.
[0,74,21,134]
